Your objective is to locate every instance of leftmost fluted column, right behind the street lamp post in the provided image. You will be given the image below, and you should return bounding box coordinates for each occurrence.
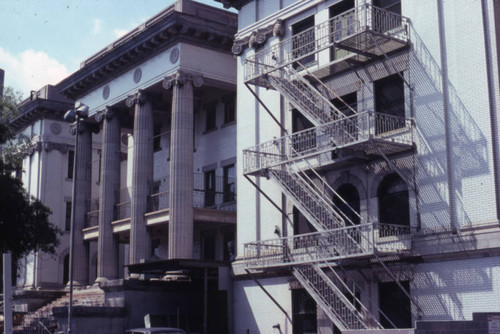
[70,121,92,285]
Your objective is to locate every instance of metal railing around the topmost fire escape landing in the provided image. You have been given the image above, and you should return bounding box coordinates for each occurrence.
[245,4,409,82]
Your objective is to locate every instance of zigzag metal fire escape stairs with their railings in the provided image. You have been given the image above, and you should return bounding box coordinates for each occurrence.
[240,5,413,330]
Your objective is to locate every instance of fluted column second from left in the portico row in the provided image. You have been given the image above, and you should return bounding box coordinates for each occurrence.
[96,108,121,281]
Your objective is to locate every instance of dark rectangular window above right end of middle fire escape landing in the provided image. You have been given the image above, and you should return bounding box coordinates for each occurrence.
[374,74,406,134]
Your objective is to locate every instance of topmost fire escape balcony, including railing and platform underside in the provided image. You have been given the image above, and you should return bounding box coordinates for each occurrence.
[244,4,409,88]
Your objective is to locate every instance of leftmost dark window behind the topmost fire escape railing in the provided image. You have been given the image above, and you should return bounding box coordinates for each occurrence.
[292,16,315,68]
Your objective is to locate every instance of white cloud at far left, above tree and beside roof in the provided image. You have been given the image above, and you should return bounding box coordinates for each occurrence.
[0,47,69,97]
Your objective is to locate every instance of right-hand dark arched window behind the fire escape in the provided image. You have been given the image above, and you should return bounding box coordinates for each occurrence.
[377,174,410,226]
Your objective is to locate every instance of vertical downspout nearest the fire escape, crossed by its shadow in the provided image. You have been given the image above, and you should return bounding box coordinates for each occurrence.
[436,0,457,234]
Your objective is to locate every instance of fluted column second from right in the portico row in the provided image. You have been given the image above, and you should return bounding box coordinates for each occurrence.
[127,92,153,263]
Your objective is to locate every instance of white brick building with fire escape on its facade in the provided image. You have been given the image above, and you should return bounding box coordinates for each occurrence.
[219,0,500,333]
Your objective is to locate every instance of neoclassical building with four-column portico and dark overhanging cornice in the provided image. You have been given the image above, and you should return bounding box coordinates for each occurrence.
[12,0,237,333]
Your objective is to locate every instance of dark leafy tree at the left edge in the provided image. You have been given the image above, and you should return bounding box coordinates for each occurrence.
[0,88,62,259]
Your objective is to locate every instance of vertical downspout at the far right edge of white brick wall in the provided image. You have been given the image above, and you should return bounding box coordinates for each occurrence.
[481,0,500,222]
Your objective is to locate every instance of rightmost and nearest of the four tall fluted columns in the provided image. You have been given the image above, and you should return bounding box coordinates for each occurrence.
[163,72,203,259]
